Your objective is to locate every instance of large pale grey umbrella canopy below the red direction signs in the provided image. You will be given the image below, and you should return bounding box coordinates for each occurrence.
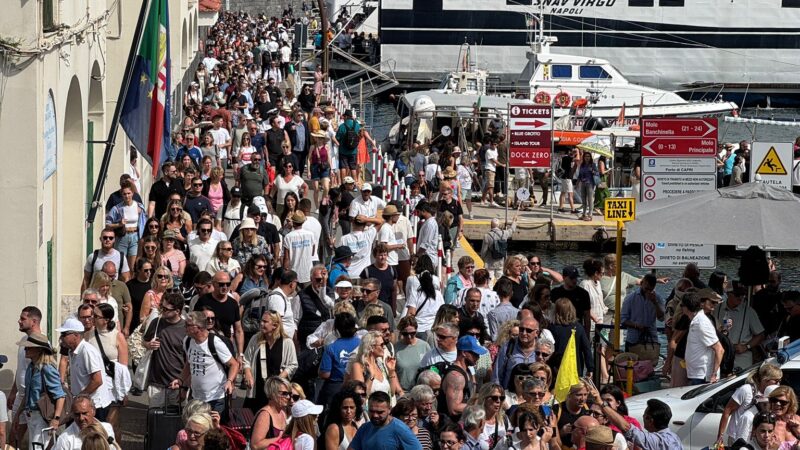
[626,183,800,250]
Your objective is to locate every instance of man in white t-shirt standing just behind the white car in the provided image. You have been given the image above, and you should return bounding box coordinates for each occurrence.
[681,293,725,385]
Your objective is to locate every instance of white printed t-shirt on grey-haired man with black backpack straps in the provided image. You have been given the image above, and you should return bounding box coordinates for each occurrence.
[186,335,233,402]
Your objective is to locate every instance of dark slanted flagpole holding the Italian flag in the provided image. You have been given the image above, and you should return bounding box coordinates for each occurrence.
[86,0,153,227]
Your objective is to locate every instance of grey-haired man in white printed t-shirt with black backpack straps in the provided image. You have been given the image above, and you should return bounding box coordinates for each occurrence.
[170,311,239,417]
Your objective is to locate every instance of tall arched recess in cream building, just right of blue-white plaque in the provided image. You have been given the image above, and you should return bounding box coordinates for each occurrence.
[60,77,86,304]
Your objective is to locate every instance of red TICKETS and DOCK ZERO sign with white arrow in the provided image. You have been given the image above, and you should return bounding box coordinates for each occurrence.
[508,105,553,169]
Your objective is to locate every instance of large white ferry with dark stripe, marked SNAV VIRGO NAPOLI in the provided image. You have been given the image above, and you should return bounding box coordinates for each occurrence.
[368,0,800,105]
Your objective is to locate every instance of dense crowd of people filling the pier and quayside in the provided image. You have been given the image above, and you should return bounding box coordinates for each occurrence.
[7,5,800,450]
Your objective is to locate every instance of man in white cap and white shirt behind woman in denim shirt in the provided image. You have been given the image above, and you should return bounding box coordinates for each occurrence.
[56,317,114,420]
